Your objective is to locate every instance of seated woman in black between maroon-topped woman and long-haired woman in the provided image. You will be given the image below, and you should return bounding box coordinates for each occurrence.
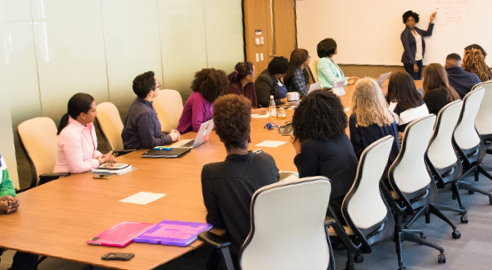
[255,56,289,108]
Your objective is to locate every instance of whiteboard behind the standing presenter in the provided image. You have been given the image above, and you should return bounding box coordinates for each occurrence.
[296,0,492,66]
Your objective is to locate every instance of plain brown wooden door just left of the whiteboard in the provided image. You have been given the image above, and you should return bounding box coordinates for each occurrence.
[272,0,297,59]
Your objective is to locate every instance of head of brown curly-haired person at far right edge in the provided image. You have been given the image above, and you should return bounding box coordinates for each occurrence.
[461,44,492,82]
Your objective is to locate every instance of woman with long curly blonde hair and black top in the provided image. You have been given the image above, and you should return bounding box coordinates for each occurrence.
[349,78,400,175]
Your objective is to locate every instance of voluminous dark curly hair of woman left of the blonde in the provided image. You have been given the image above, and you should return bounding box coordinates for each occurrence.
[292,90,347,142]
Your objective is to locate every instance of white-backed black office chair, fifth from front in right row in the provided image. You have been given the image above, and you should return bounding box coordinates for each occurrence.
[453,87,492,204]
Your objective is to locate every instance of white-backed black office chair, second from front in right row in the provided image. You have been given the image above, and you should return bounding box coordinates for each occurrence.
[329,135,395,270]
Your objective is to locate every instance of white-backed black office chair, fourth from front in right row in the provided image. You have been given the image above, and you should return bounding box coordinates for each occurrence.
[425,100,468,223]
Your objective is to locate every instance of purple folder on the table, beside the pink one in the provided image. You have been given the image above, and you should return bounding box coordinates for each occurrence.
[133,220,213,247]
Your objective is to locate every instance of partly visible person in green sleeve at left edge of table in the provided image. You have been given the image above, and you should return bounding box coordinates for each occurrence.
[0,155,38,270]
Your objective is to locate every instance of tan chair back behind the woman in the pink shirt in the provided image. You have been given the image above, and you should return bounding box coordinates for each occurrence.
[17,117,58,183]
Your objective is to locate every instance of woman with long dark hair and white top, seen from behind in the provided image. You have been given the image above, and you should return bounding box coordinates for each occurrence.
[386,71,429,132]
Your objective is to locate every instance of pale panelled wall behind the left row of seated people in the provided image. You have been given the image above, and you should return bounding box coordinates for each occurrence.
[0,0,244,182]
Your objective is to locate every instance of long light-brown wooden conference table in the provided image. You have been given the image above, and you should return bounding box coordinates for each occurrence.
[0,79,422,269]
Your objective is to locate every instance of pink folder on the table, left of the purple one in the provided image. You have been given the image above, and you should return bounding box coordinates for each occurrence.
[87,222,154,247]
